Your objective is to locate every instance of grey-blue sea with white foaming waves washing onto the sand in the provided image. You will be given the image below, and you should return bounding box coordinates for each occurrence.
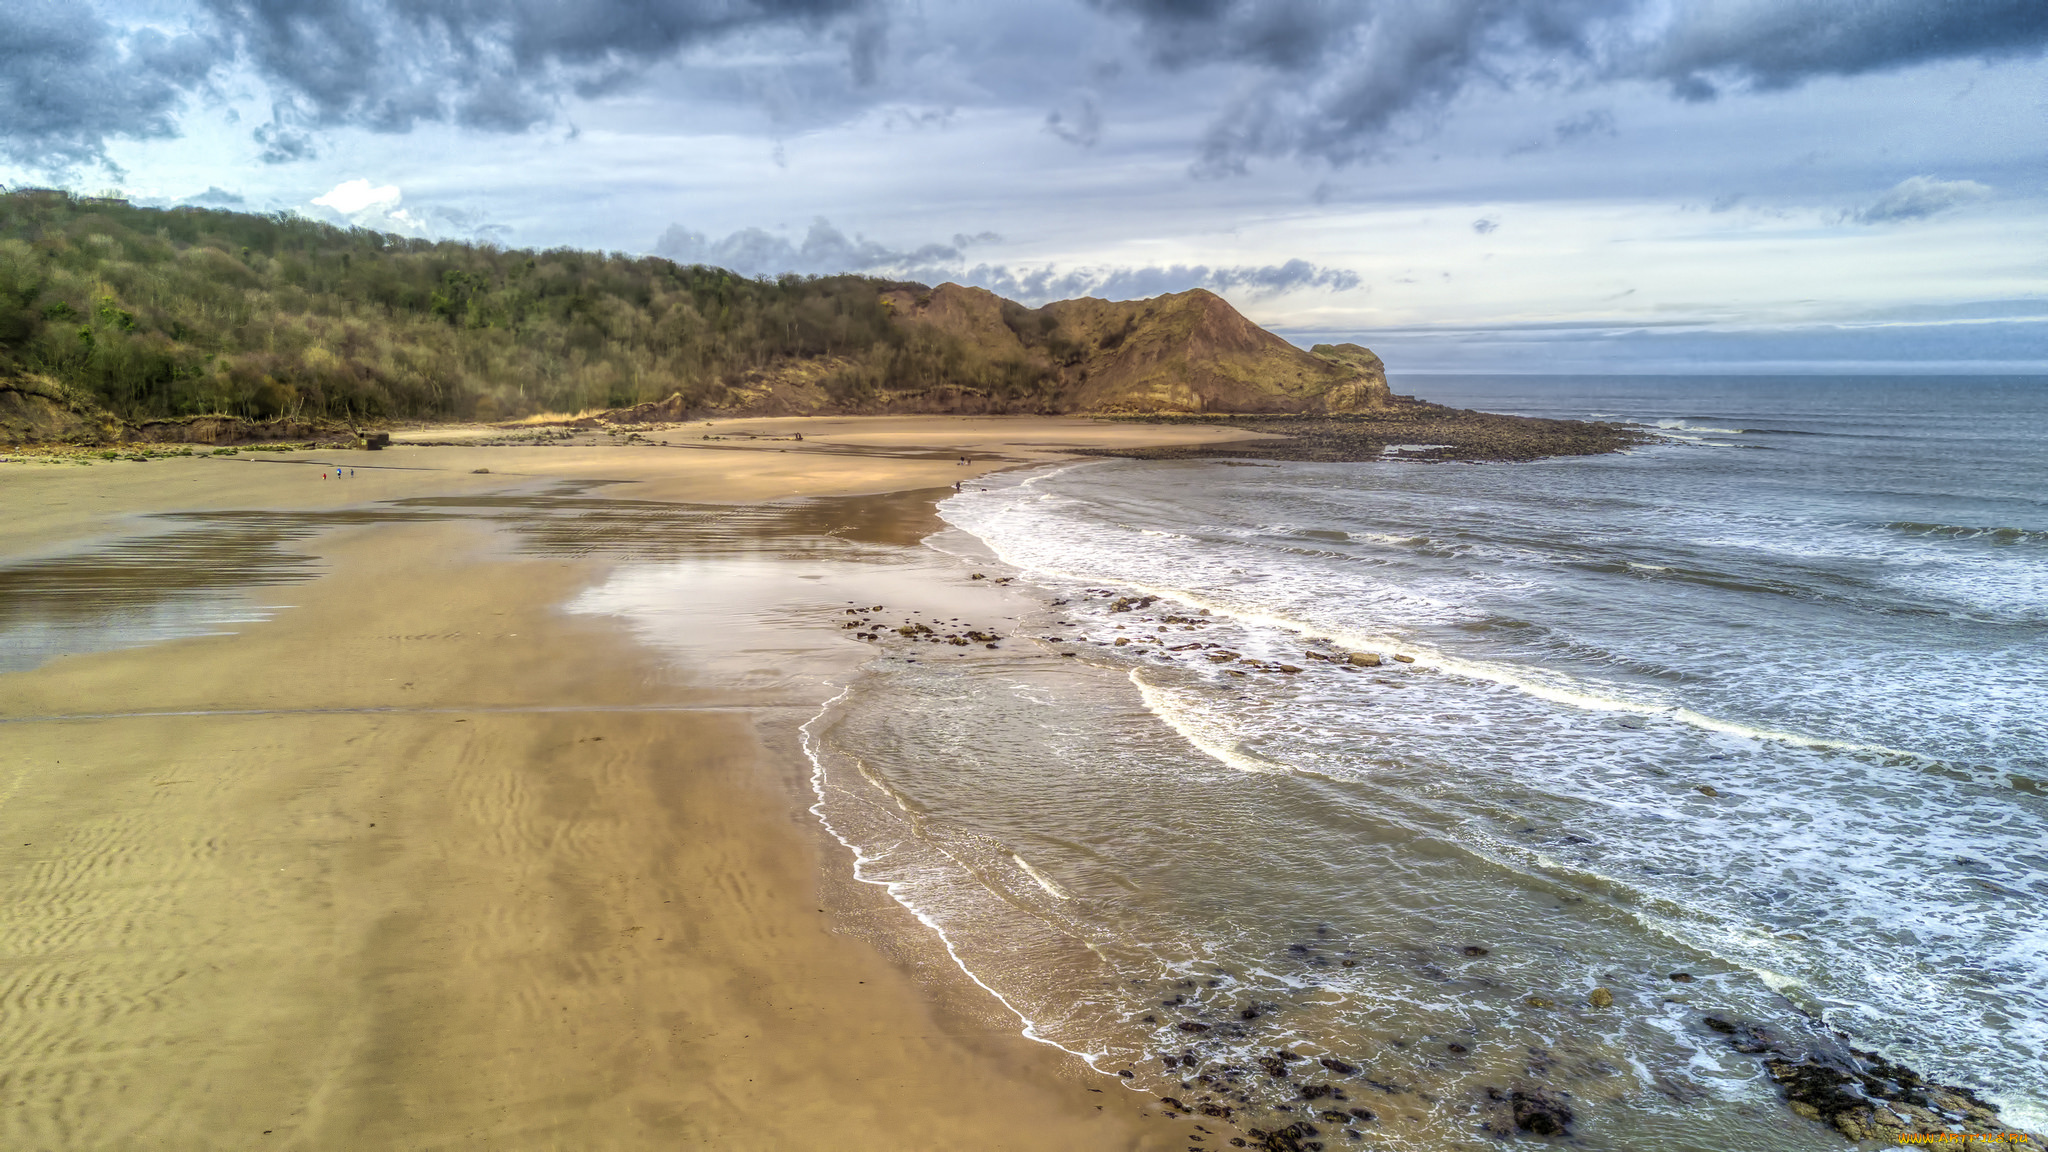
[805,377,2048,1152]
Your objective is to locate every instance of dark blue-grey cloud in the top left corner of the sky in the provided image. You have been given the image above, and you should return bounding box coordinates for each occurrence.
[0,0,219,172]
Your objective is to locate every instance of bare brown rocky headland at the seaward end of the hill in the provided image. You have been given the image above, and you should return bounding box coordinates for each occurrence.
[864,283,1389,414]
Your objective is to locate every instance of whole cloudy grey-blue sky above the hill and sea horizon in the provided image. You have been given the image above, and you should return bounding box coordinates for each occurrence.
[0,0,2048,366]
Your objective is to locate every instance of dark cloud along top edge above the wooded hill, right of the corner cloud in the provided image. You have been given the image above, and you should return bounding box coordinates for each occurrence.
[205,0,883,131]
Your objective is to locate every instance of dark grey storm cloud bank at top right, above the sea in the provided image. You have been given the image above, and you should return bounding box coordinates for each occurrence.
[1096,0,2048,172]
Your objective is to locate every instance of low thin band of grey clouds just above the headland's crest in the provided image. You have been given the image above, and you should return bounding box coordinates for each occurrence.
[655,213,1360,303]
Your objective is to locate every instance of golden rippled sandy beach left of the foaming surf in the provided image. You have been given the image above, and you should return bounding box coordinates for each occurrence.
[0,418,1239,1150]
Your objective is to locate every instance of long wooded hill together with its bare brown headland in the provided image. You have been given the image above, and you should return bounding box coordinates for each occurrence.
[0,191,1386,428]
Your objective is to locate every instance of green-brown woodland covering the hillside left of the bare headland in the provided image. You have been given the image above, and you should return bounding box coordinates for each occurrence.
[0,191,1047,420]
